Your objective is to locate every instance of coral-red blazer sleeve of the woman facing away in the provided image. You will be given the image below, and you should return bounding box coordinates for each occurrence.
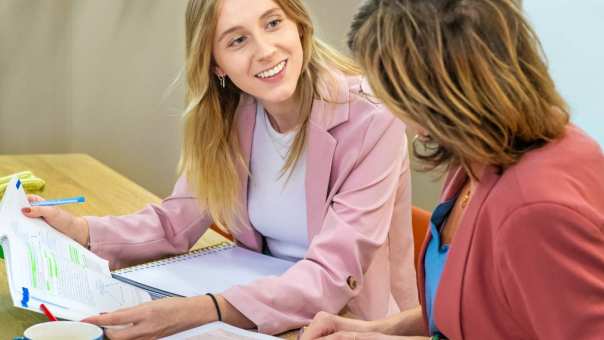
[496,202,604,340]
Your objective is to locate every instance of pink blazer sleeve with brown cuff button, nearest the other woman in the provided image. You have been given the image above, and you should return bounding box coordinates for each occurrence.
[223,114,409,334]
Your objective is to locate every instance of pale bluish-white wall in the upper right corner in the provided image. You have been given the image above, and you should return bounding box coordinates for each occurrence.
[524,0,604,146]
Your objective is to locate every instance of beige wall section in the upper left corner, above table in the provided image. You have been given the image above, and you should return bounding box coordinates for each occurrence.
[0,0,72,154]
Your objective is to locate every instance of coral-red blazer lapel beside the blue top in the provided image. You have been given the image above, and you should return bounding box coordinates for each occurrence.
[434,166,499,339]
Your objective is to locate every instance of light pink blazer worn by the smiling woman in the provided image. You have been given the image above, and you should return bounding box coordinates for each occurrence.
[87,76,418,334]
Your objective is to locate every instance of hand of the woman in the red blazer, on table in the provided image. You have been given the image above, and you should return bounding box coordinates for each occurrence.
[300,312,375,340]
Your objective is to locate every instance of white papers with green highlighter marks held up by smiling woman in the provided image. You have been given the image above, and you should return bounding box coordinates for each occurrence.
[0,178,151,320]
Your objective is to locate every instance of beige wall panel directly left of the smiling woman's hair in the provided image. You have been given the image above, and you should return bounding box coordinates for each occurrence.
[70,0,186,196]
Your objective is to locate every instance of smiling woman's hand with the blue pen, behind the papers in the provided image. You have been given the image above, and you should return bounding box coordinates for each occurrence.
[21,195,90,247]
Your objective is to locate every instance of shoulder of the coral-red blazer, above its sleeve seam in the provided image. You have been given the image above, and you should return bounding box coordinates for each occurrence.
[485,125,604,232]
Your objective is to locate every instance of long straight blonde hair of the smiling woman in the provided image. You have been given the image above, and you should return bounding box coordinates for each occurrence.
[179,0,360,231]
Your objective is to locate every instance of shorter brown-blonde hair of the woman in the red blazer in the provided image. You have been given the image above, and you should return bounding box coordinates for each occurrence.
[348,0,569,175]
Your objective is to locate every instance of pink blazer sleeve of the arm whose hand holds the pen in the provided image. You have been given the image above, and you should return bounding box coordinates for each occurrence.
[86,177,210,268]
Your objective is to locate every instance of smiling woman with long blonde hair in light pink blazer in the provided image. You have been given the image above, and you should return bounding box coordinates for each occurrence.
[26,0,418,339]
